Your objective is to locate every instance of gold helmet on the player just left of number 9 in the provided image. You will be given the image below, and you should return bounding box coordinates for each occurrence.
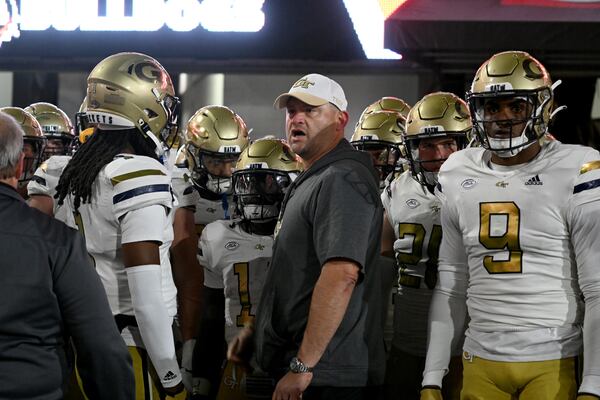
[403,92,472,187]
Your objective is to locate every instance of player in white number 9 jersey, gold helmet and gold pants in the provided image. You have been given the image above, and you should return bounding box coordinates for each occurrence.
[422,51,600,400]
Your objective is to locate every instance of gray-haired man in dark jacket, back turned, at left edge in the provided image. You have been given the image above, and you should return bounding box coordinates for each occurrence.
[0,112,134,400]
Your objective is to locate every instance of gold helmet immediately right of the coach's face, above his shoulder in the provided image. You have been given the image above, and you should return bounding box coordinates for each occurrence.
[350,111,406,182]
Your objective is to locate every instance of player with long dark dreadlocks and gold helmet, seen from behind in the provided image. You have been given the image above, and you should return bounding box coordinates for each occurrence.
[57,53,186,399]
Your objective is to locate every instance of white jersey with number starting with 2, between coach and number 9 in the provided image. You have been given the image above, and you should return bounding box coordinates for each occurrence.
[381,171,442,357]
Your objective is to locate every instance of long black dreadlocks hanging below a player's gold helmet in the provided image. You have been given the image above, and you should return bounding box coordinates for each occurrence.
[54,128,157,210]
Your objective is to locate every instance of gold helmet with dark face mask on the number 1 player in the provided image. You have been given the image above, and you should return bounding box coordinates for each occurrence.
[232,138,303,223]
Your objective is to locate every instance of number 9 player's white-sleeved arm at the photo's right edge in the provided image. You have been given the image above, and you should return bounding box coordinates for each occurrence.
[567,157,600,396]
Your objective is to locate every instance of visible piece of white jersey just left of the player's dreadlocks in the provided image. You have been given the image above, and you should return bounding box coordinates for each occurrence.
[27,156,75,228]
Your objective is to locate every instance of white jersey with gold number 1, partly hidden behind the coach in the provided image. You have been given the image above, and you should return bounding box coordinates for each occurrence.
[198,220,273,342]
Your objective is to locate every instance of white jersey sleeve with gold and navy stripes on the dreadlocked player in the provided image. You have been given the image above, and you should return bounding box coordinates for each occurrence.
[106,155,174,219]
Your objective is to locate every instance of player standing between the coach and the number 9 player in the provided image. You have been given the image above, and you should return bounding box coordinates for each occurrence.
[382,92,471,400]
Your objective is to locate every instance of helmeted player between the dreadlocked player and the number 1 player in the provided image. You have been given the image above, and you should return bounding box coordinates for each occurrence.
[172,106,248,389]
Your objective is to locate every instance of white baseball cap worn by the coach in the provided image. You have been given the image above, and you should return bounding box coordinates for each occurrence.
[273,74,348,111]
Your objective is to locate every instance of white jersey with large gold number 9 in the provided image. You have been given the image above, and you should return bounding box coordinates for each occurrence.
[439,141,599,361]
